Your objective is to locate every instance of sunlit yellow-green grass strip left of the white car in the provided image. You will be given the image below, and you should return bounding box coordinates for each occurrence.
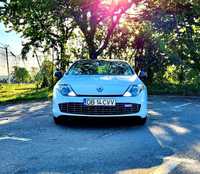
[0,84,52,104]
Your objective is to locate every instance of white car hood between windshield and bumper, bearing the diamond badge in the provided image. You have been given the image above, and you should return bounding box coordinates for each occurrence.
[59,74,141,96]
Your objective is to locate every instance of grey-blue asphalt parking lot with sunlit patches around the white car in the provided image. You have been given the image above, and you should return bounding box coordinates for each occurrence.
[0,96,200,174]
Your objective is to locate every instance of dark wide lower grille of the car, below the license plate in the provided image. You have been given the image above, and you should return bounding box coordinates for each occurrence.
[59,103,141,115]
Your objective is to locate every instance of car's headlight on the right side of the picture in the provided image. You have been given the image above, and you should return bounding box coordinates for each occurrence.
[124,84,145,97]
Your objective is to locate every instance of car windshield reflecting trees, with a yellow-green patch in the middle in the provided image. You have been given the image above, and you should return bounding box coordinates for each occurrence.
[68,60,134,75]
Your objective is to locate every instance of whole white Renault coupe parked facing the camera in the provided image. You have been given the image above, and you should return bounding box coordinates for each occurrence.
[53,60,147,124]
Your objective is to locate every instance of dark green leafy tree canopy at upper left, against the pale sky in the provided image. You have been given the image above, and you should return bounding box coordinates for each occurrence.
[0,0,75,64]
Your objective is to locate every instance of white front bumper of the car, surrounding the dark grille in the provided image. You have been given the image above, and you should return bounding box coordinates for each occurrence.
[52,89,147,118]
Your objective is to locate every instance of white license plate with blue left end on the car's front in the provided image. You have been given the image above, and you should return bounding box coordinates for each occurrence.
[84,99,116,106]
